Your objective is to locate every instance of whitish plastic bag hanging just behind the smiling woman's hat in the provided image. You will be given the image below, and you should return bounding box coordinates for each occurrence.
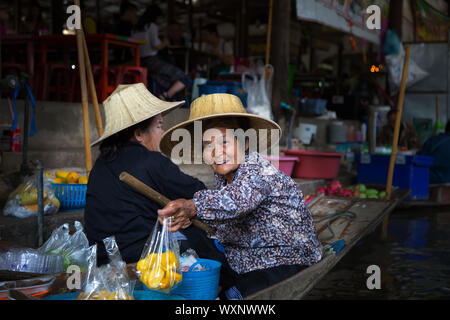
[242,61,273,119]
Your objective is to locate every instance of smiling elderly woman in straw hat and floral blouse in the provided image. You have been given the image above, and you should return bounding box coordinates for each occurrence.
[158,94,322,296]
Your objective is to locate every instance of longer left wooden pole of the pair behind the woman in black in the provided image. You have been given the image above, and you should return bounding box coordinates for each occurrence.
[75,0,92,175]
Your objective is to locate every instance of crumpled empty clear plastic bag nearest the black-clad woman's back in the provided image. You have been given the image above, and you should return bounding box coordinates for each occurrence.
[38,221,89,272]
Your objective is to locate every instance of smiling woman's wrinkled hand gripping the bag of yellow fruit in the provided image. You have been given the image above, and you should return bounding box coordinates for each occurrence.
[158,199,196,232]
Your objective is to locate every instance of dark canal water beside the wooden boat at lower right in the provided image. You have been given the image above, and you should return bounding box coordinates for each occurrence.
[305,210,450,300]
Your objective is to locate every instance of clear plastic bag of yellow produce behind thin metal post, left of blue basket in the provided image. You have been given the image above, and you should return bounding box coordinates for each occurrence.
[3,175,60,218]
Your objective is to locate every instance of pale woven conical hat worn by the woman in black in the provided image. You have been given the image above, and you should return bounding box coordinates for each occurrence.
[91,83,184,147]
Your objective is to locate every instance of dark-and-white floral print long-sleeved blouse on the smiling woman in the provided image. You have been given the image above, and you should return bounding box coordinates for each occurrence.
[193,152,322,274]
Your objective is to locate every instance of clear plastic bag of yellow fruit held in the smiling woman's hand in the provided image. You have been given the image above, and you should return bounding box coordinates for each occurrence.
[136,218,182,293]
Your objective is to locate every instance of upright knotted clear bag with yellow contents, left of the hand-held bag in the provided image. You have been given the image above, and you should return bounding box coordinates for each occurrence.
[77,236,135,300]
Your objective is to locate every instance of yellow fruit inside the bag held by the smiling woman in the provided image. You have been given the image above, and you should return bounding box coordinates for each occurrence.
[136,250,182,290]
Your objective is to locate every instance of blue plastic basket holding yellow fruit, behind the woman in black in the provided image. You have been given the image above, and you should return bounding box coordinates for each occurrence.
[52,183,87,211]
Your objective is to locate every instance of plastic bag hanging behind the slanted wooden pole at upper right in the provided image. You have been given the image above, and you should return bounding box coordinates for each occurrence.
[385,44,430,94]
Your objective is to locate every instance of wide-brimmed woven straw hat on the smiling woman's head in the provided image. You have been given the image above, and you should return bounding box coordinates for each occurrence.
[159,93,281,161]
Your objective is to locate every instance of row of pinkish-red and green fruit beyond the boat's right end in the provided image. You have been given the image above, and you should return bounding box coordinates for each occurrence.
[305,180,386,204]
